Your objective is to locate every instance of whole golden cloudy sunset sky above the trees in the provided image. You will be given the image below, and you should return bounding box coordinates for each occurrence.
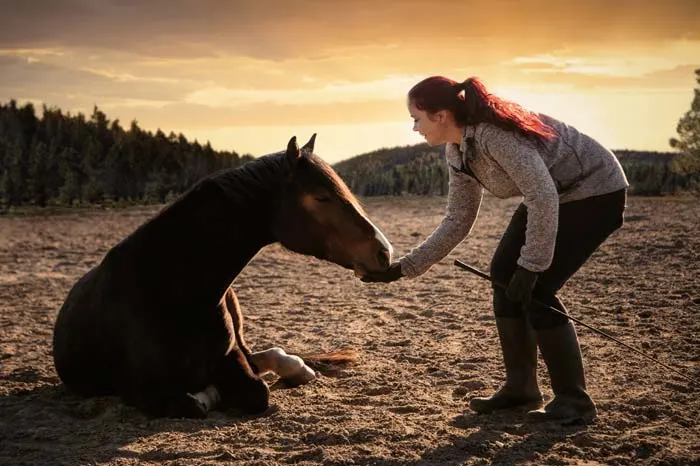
[0,0,700,163]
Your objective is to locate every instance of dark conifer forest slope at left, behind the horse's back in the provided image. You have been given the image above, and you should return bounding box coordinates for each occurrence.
[0,101,252,210]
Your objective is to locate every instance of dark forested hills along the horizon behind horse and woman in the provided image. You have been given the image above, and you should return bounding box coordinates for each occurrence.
[0,101,700,211]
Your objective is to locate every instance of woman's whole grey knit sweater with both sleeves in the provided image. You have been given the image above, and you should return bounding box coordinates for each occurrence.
[400,115,629,278]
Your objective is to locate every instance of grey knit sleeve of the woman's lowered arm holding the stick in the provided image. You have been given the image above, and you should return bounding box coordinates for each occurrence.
[482,127,559,272]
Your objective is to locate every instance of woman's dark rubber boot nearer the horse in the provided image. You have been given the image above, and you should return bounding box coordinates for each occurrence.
[469,317,542,413]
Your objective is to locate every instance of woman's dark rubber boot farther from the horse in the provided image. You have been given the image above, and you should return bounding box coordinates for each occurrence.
[526,322,597,424]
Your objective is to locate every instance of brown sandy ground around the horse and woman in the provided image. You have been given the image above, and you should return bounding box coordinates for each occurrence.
[0,198,700,465]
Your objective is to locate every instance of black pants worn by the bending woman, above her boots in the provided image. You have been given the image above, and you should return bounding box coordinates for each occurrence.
[491,189,627,330]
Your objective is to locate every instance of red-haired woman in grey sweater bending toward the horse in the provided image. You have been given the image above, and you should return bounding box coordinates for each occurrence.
[362,76,629,423]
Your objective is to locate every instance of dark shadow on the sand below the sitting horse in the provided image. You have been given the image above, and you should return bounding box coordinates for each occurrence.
[0,369,277,466]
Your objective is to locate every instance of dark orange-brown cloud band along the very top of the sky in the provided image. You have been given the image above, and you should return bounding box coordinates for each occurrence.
[0,0,700,60]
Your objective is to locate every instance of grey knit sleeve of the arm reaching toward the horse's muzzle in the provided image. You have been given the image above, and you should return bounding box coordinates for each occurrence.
[399,151,483,278]
